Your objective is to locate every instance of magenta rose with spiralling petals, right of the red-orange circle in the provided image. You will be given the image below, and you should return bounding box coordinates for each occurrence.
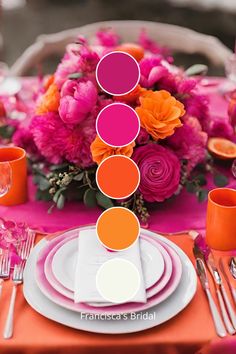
[132,143,180,202]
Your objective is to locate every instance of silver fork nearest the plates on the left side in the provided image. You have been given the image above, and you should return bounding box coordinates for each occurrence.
[3,231,35,339]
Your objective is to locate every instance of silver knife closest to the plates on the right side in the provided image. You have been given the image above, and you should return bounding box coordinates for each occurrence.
[196,258,227,337]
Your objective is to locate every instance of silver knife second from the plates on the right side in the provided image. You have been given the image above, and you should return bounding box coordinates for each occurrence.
[207,252,236,334]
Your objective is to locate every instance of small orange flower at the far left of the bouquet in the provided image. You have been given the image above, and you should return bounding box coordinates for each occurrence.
[36,83,60,114]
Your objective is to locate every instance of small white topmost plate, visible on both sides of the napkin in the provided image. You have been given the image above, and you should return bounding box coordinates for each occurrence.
[52,238,165,292]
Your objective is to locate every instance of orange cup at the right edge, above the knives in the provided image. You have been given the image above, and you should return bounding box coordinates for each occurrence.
[206,188,236,251]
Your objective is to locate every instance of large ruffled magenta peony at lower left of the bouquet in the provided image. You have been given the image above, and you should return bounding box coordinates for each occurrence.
[31,112,96,167]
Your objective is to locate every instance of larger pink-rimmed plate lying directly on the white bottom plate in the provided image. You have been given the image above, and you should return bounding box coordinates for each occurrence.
[35,226,182,314]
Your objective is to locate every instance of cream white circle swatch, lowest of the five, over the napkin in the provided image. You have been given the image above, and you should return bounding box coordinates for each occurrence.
[96,258,140,304]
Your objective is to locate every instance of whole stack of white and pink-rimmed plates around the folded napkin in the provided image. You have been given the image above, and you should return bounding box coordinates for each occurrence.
[24,226,197,333]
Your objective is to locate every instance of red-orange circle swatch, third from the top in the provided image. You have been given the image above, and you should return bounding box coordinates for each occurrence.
[96,155,140,199]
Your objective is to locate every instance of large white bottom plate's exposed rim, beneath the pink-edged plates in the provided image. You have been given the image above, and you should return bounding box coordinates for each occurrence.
[23,227,197,334]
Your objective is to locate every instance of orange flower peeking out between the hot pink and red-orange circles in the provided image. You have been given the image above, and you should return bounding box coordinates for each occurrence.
[90,135,135,165]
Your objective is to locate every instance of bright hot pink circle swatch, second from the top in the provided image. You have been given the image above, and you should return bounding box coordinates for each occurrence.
[96,103,140,147]
